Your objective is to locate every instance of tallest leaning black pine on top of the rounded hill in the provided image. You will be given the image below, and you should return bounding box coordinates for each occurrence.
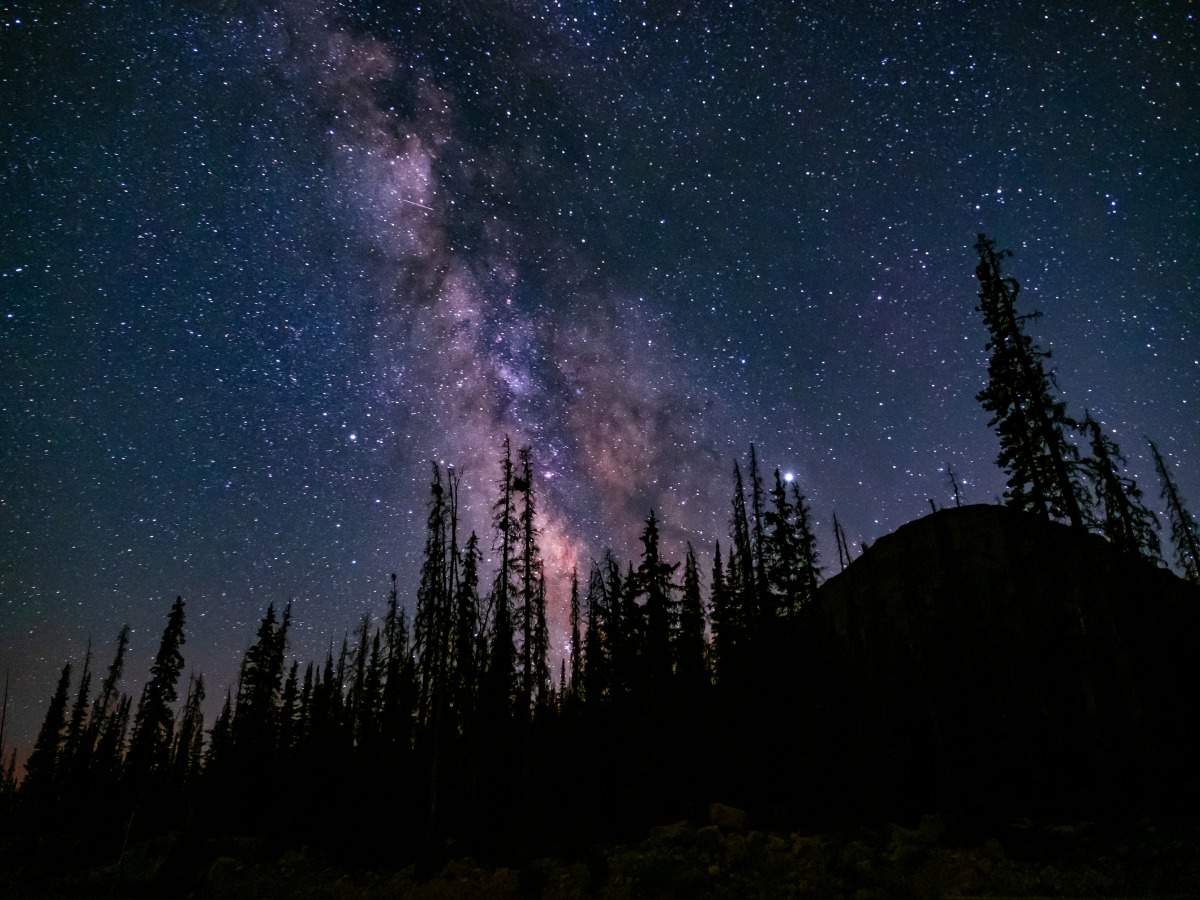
[976,234,1084,528]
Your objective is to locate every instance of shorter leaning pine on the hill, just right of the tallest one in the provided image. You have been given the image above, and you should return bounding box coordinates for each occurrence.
[1080,413,1163,563]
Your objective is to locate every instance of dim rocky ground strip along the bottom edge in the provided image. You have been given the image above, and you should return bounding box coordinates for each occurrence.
[5,817,1200,900]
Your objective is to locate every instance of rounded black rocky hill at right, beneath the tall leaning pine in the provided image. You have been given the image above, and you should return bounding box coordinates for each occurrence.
[811,505,1200,816]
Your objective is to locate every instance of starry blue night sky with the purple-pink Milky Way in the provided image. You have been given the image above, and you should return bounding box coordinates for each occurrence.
[0,0,1200,763]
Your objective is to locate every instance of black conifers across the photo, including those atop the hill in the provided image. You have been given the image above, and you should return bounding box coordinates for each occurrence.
[0,235,1200,860]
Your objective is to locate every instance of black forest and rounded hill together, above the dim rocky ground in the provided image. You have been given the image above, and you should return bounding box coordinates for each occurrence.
[0,235,1200,892]
